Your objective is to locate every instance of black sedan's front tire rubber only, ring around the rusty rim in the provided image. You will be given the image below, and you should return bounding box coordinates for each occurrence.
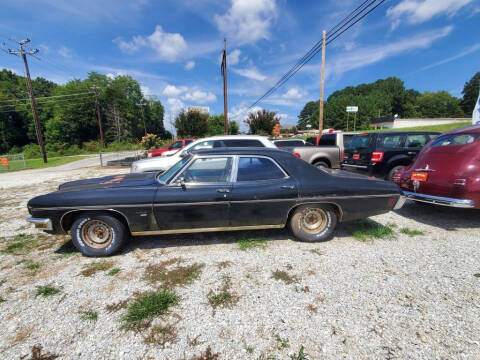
[71,214,126,257]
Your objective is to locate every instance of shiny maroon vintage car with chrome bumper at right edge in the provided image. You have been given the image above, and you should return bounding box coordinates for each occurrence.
[392,125,480,209]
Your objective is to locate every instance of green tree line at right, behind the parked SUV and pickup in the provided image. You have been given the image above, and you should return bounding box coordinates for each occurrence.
[297,72,480,130]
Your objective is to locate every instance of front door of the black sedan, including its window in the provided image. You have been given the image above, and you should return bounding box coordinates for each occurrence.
[153,155,233,230]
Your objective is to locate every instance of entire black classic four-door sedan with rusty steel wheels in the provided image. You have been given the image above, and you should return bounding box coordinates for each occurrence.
[27,148,404,256]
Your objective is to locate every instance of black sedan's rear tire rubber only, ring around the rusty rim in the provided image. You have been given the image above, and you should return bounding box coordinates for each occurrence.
[290,204,338,242]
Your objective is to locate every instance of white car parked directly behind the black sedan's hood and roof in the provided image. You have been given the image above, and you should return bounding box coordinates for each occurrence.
[130,135,277,173]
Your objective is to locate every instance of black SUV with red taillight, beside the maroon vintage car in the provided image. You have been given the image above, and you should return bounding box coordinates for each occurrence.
[341,131,439,180]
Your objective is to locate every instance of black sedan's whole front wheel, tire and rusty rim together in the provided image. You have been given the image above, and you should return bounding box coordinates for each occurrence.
[71,212,128,256]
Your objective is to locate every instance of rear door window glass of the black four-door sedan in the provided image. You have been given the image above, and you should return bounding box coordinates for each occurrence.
[237,157,285,182]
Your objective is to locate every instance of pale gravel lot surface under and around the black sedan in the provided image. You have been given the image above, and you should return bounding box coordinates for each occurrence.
[0,164,480,360]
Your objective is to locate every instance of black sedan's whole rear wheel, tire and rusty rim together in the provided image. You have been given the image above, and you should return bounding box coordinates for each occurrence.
[290,204,338,242]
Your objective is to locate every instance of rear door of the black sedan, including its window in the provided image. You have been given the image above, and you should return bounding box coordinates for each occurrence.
[230,155,298,227]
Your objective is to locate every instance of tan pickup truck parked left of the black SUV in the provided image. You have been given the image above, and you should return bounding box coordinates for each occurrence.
[284,131,355,169]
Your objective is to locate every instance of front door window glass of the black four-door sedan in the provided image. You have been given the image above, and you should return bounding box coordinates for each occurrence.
[177,157,232,183]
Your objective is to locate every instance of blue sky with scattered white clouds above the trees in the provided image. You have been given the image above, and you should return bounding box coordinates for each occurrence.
[0,0,480,130]
